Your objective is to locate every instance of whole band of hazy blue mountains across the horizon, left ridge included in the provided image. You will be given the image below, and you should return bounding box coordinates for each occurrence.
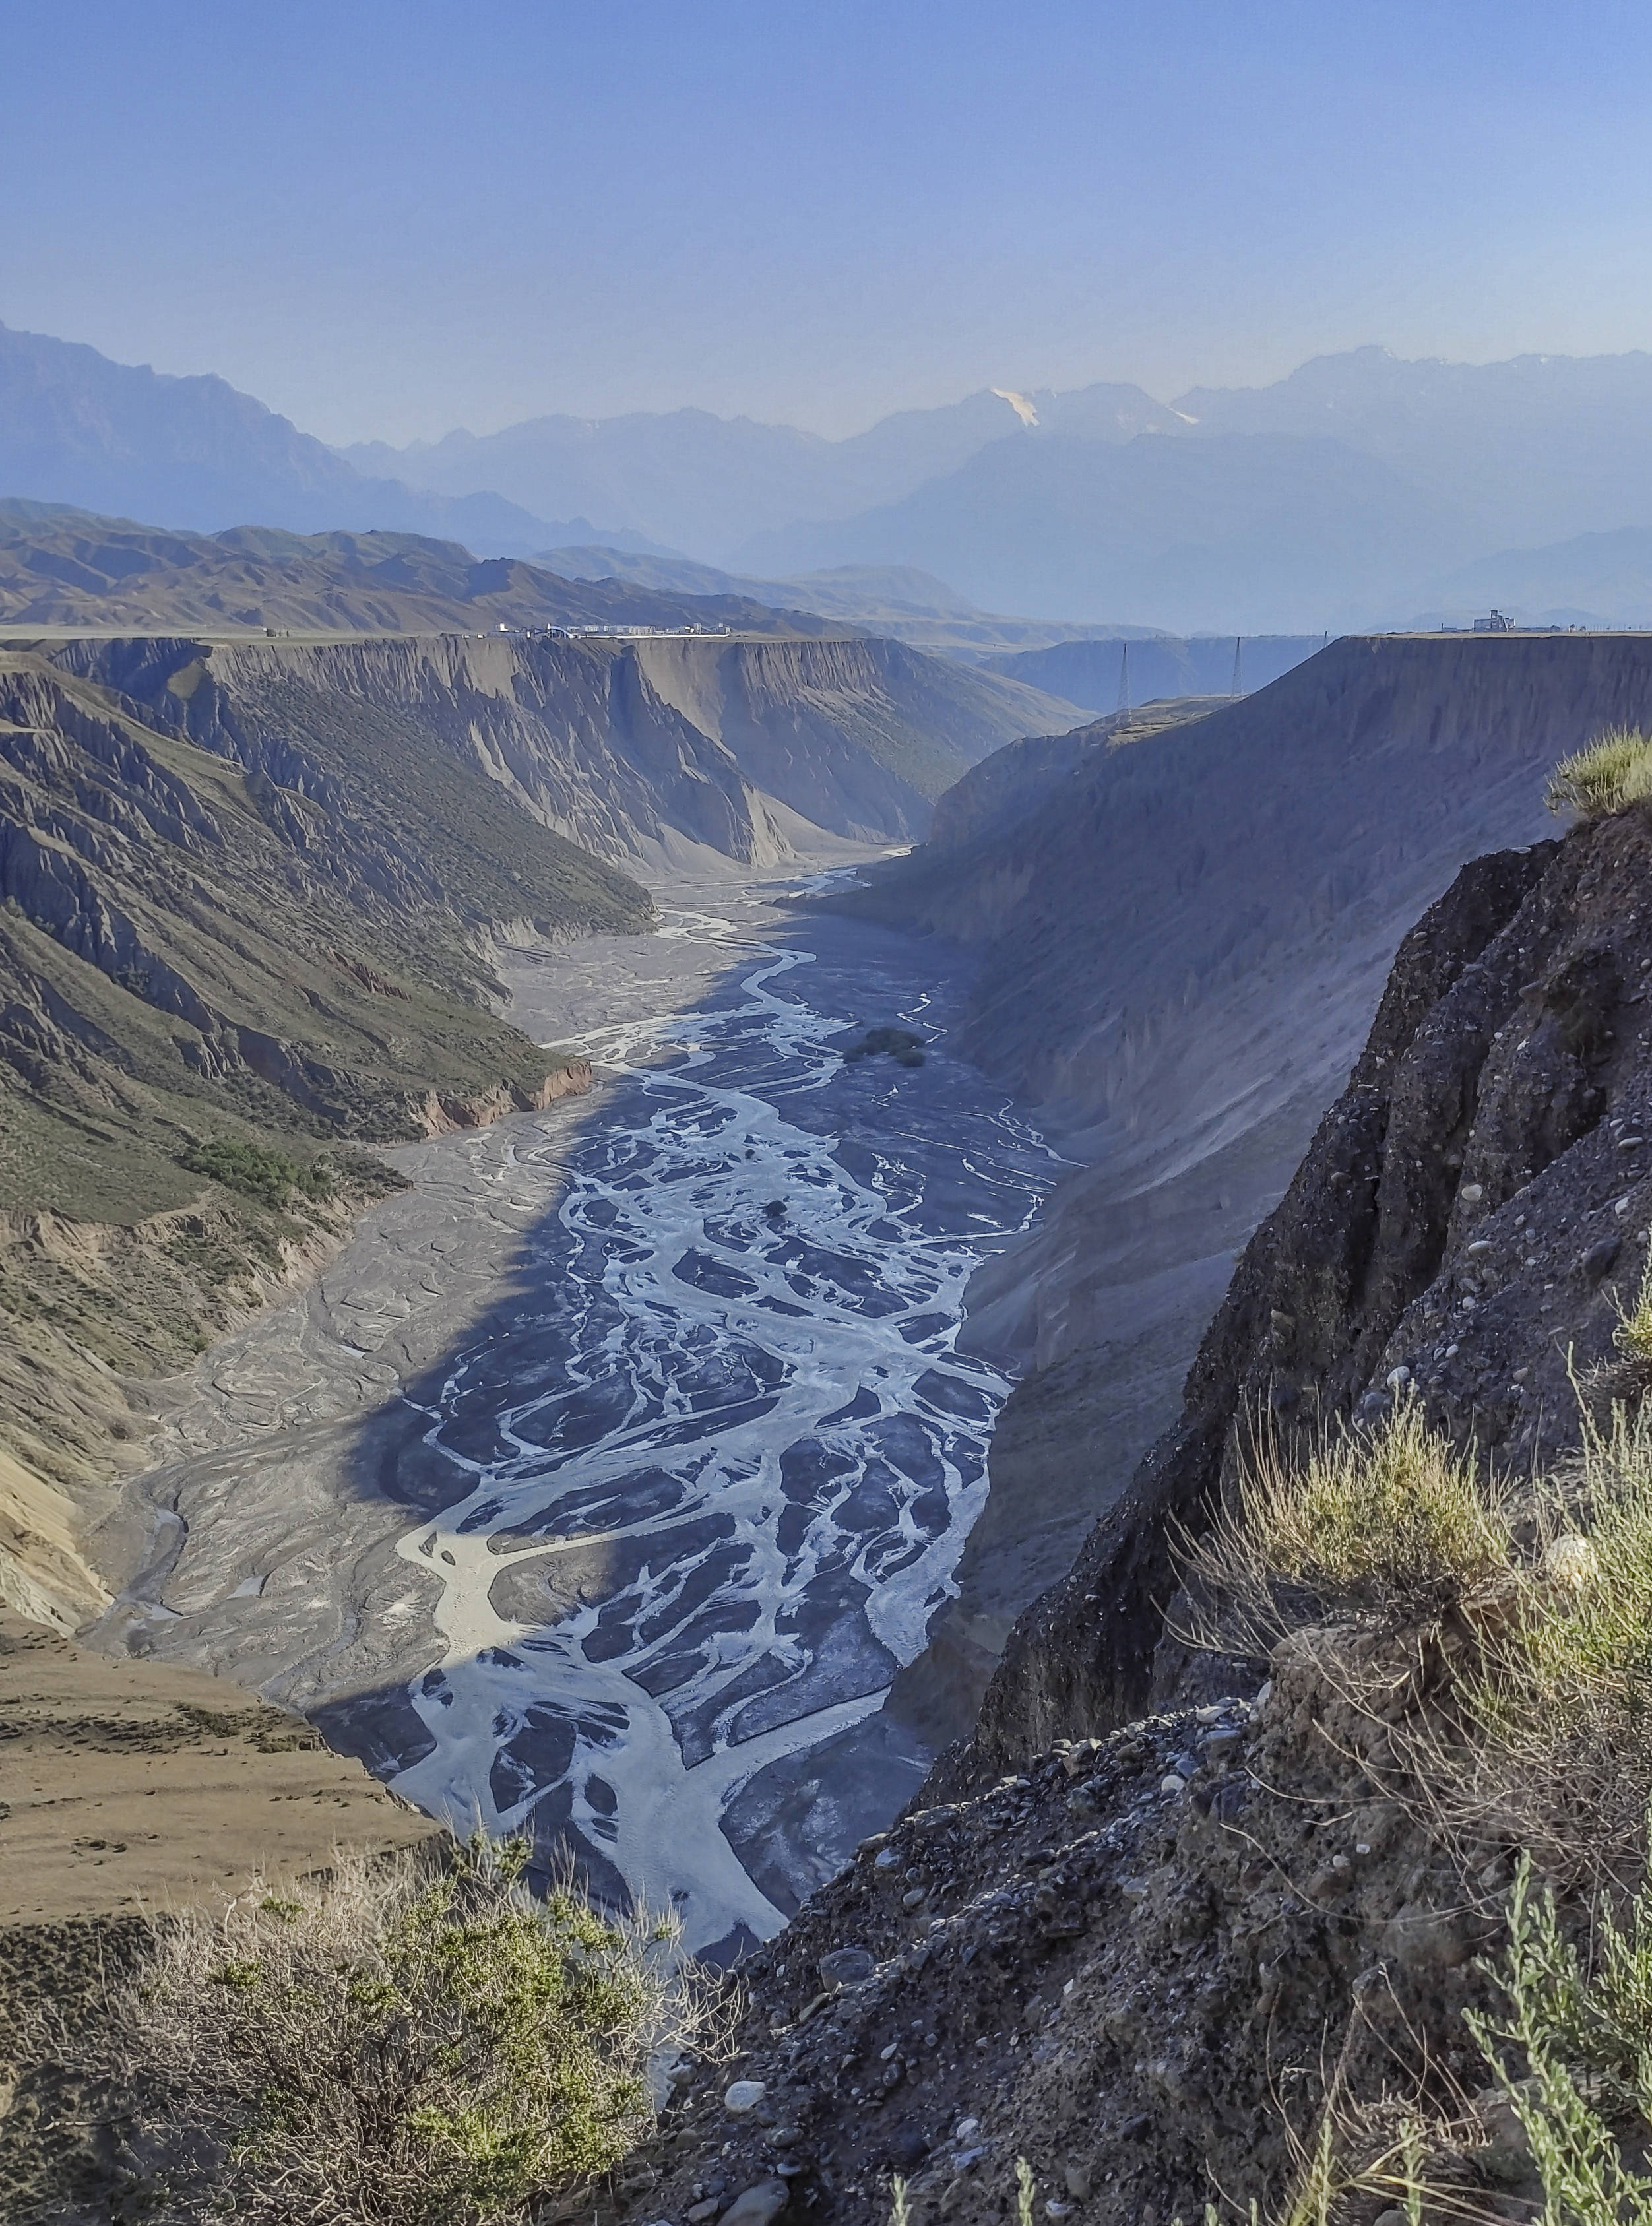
[16,313,1652,632]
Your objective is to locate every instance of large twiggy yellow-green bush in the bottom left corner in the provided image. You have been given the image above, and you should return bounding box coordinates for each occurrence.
[40,1843,708,2226]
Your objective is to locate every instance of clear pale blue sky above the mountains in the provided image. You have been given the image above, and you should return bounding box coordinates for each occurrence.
[13,0,1652,447]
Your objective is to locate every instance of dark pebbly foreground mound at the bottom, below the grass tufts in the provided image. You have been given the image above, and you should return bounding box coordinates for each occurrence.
[617,1649,1529,2226]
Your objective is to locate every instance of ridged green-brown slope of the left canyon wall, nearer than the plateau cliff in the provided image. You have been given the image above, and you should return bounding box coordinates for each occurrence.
[0,654,650,1478]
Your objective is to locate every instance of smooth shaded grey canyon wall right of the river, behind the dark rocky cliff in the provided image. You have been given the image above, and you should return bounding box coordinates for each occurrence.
[848,635,1652,1740]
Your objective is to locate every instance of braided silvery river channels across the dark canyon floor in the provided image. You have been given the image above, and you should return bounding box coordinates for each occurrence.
[96,879,1060,1952]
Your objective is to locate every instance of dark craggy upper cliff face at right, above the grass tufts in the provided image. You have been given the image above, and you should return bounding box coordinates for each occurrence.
[966,808,1652,1783]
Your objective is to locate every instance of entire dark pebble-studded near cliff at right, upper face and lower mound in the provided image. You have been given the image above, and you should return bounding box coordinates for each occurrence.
[619,804,1652,2226]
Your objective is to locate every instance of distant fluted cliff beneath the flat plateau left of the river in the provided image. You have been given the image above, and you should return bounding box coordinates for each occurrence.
[62,635,1073,866]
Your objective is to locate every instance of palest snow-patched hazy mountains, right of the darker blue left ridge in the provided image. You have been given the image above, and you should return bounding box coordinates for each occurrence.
[356,347,1652,632]
